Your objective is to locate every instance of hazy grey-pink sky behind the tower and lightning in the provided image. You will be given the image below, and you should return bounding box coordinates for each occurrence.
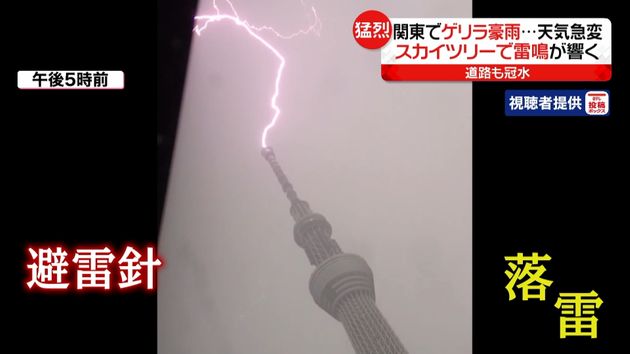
[158,0,472,354]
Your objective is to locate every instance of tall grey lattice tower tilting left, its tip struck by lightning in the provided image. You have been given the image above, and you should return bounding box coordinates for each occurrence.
[262,148,407,354]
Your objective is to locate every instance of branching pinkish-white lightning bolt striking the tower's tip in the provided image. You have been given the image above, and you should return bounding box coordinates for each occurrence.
[193,0,322,148]
